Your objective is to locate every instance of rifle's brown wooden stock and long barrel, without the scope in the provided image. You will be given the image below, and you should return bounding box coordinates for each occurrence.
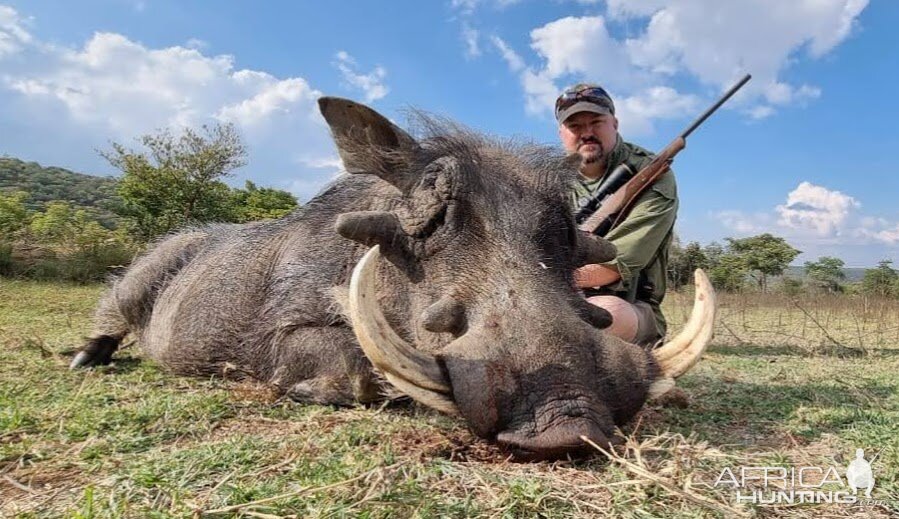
[579,74,751,236]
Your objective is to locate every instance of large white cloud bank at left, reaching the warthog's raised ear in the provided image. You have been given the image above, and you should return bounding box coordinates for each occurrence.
[0,6,339,198]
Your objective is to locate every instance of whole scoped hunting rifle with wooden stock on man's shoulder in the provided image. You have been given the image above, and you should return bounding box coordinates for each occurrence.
[575,74,752,236]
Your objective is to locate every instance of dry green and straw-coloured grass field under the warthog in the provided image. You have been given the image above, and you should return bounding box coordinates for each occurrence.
[0,279,899,518]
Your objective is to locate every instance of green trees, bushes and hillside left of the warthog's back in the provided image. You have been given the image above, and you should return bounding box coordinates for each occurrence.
[0,125,297,282]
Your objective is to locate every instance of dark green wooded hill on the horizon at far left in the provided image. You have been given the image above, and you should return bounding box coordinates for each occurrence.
[0,157,118,227]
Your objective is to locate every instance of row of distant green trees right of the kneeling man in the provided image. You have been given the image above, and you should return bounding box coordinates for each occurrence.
[668,233,899,299]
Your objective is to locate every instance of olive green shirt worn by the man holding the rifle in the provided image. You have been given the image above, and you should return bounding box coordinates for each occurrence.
[571,135,678,337]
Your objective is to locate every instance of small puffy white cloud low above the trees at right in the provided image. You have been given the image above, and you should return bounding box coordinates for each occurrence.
[775,182,861,236]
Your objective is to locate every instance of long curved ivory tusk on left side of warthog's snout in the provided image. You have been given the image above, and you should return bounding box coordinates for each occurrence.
[349,245,458,414]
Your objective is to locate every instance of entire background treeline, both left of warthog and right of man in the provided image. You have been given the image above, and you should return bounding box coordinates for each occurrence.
[0,125,899,298]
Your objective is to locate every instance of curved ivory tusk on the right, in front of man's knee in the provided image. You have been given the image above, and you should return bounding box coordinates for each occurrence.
[652,269,715,379]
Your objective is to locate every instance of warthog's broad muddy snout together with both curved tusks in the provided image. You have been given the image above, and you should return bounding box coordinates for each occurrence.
[349,247,714,460]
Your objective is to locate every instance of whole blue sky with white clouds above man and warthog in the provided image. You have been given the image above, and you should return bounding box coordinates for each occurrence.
[0,0,899,267]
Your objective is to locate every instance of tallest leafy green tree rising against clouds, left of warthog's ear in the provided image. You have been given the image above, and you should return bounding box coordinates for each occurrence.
[101,124,246,240]
